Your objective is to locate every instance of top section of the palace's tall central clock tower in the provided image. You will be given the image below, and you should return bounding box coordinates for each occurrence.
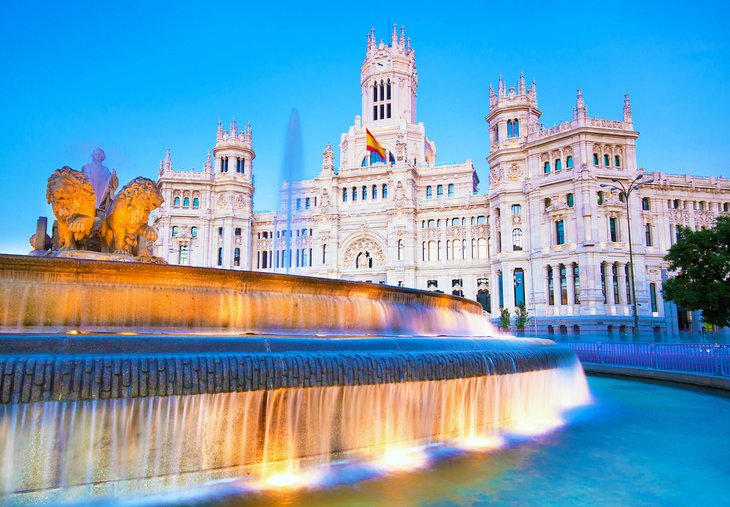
[360,25,418,127]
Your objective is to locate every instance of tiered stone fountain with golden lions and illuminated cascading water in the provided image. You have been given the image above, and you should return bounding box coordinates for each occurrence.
[0,157,589,503]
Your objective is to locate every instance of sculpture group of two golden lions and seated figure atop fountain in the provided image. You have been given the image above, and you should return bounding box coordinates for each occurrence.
[30,148,164,263]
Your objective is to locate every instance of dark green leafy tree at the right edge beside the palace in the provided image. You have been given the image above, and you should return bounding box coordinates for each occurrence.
[662,215,730,326]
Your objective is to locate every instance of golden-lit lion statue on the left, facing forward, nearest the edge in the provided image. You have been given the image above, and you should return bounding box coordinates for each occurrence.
[46,166,96,250]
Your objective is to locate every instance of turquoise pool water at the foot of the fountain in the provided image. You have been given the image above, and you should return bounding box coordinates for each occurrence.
[168,377,730,507]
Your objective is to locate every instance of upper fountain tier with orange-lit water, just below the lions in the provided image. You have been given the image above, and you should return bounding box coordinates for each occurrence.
[0,255,489,336]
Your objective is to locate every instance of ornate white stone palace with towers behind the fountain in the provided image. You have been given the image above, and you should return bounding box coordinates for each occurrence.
[154,27,730,339]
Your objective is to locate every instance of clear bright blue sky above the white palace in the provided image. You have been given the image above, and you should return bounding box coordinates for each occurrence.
[0,0,730,253]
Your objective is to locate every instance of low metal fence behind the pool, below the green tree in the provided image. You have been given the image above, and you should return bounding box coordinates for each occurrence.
[560,341,730,377]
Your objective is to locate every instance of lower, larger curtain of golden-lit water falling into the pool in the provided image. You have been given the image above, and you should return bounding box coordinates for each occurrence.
[0,363,588,499]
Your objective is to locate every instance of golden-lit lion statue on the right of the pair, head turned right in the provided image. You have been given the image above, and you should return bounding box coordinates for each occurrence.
[101,176,165,255]
